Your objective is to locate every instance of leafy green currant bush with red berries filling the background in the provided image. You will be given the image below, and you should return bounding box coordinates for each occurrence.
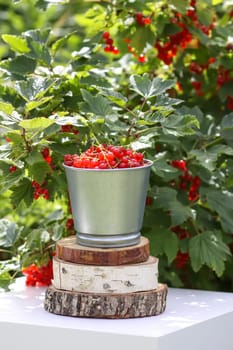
[0,0,233,290]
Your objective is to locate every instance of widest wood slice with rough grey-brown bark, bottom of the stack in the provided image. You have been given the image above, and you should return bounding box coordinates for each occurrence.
[44,284,168,319]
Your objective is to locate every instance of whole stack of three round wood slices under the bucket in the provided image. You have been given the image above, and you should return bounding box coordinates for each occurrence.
[44,236,167,318]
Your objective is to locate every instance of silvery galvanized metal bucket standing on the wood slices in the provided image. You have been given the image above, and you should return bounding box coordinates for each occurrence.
[64,160,152,248]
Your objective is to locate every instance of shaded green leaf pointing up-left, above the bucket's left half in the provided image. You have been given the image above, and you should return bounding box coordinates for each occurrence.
[81,89,114,117]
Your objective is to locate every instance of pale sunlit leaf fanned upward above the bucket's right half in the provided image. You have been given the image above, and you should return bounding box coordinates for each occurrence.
[130,74,175,99]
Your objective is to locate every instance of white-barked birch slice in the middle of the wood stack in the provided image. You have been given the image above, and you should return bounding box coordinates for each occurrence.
[53,256,158,293]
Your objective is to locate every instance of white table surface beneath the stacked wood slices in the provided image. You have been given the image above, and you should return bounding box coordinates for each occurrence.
[0,278,233,350]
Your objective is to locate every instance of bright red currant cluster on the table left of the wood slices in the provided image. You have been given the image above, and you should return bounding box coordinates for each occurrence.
[22,260,53,287]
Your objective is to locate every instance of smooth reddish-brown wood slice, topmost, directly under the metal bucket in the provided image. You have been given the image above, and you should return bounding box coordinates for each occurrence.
[56,236,150,266]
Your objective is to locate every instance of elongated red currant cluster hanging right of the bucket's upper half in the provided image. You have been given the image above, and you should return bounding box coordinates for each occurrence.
[171,160,201,202]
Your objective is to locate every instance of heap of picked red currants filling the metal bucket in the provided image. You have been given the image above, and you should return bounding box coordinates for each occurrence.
[64,145,145,169]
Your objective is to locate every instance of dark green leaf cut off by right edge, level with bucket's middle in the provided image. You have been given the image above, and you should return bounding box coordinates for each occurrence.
[203,188,233,233]
